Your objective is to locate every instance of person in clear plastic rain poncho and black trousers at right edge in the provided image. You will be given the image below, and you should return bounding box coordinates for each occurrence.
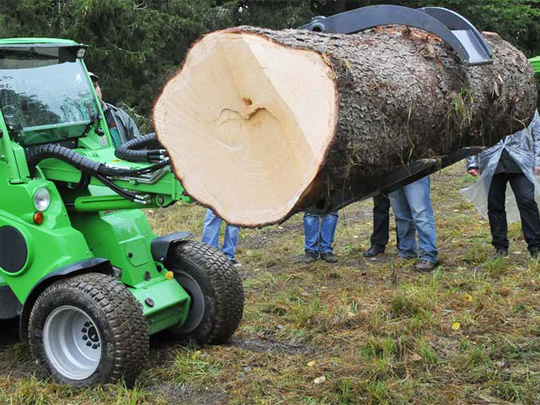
[462,111,540,259]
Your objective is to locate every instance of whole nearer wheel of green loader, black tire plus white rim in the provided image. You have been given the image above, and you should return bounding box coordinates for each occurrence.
[28,273,149,386]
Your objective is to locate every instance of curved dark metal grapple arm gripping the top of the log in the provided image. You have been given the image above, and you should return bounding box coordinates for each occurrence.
[299,5,492,65]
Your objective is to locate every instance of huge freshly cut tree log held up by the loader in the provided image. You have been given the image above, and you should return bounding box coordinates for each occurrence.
[154,27,537,226]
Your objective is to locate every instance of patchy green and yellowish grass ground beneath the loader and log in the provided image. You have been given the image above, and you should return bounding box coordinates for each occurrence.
[0,163,540,405]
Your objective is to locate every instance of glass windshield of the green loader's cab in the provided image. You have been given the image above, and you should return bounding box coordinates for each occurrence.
[0,47,98,146]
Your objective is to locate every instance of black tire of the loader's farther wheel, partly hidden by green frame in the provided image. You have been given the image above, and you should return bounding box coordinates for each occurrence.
[166,241,244,344]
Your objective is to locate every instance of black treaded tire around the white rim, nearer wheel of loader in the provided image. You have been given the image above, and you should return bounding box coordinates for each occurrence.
[28,273,149,386]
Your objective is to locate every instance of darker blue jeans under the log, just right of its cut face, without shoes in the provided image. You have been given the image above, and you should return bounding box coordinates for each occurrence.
[304,211,338,253]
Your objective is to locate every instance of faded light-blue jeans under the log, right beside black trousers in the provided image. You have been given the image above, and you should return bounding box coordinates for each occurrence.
[389,177,439,263]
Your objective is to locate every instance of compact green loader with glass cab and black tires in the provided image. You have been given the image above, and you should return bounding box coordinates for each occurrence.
[0,38,244,385]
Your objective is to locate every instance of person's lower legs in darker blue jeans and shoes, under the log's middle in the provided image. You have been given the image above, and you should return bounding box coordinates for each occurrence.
[302,211,339,263]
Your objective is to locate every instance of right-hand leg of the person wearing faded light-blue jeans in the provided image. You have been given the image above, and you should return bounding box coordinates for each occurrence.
[403,176,439,263]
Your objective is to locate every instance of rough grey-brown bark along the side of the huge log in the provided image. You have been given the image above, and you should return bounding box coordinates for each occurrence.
[158,27,537,226]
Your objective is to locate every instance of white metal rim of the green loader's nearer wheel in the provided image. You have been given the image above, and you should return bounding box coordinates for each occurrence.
[43,305,102,381]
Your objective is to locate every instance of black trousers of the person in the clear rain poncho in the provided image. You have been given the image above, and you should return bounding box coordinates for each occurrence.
[488,173,540,252]
